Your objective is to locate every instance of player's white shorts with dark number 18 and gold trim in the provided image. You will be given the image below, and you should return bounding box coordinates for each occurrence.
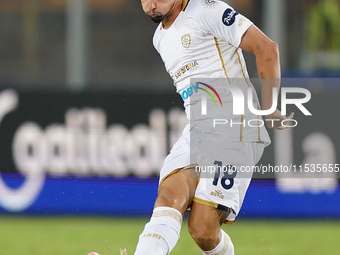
[160,126,265,222]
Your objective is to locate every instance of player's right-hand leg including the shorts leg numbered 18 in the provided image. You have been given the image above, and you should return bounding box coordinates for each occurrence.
[189,140,264,255]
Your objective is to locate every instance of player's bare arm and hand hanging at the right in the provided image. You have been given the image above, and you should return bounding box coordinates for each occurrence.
[239,25,294,129]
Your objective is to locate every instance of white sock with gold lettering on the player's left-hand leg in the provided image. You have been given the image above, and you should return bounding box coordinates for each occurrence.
[135,206,182,255]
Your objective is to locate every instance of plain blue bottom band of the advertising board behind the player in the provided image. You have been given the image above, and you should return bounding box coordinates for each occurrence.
[0,175,340,219]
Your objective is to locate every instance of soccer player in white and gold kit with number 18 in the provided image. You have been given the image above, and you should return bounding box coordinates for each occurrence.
[131,0,293,255]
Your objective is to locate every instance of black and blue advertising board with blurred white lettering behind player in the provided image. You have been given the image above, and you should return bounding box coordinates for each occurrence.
[0,85,340,218]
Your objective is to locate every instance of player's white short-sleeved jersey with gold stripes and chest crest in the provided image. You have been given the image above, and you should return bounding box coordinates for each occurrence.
[153,0,270,143]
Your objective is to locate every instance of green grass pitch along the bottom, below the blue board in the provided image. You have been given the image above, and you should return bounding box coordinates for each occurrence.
[0,216,340,255]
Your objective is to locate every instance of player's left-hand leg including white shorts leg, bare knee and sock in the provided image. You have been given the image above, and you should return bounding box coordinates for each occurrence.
[135,126,198,255]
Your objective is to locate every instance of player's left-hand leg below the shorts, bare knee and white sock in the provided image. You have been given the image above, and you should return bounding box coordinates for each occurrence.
[135,169,197,255]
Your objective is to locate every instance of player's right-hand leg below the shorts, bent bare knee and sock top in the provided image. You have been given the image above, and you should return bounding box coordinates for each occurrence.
[189,202,234,255]
